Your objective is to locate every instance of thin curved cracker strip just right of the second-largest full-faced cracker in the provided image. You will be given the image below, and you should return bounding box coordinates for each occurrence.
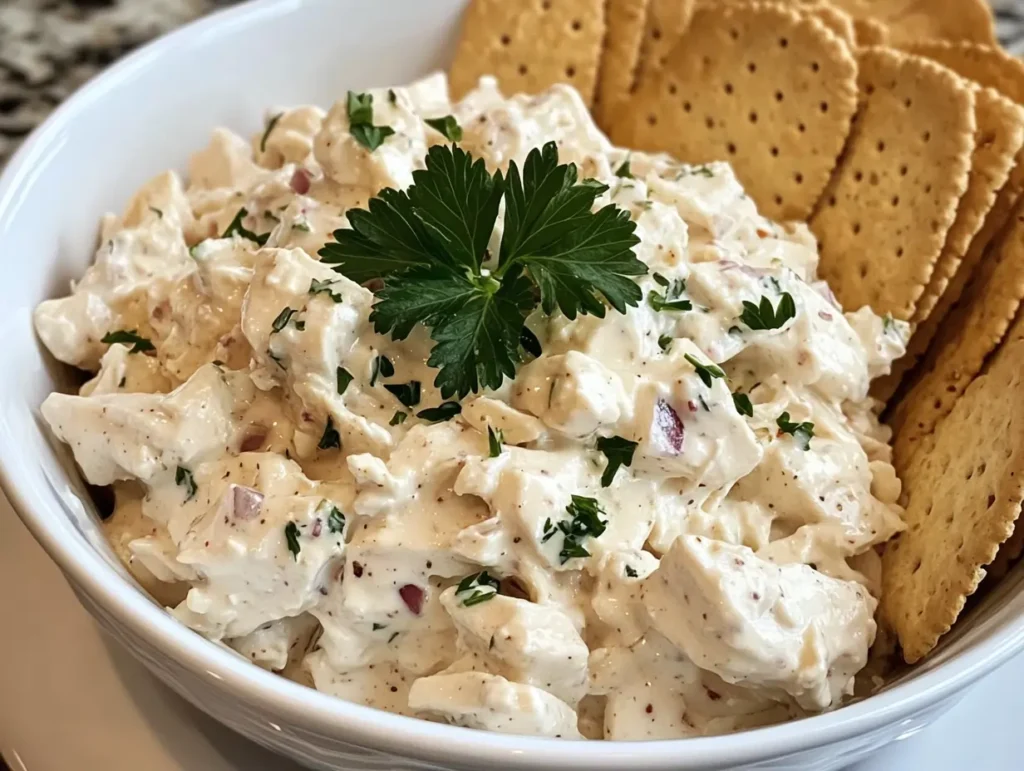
[871,88,1024,401]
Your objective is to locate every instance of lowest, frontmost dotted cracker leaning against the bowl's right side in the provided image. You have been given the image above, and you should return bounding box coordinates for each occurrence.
[881,343,1024,663]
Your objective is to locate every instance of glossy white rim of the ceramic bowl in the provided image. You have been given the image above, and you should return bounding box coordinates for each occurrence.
[0,0,1024,771]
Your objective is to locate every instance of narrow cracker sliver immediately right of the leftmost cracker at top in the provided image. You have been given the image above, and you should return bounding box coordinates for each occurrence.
[594,0,650,128]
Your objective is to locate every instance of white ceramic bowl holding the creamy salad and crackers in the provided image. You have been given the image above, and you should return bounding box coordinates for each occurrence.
[6,0,1024,771]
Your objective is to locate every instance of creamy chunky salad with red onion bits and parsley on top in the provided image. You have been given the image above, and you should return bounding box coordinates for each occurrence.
[35,76,906,739]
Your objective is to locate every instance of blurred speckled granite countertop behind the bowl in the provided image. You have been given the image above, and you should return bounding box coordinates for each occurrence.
[6,0,1024,166]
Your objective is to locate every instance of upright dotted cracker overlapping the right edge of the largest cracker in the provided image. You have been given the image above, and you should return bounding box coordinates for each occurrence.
[810,48,976,320]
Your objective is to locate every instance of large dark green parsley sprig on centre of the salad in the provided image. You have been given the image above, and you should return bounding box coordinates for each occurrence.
[319,142,647,398]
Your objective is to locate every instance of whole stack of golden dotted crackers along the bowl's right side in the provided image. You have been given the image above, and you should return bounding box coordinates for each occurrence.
[451,0,1024,662]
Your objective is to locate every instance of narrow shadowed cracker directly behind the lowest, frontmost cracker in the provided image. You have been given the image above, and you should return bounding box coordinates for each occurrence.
[888,206,1024,462]
